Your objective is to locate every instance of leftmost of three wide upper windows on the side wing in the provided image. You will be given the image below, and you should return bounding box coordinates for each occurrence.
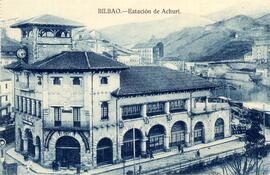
[122,105,141,120]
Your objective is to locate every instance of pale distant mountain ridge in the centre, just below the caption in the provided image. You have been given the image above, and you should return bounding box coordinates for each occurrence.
[100,14,213,46]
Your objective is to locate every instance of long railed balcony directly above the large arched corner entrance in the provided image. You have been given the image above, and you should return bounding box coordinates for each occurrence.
[43,120,90,131]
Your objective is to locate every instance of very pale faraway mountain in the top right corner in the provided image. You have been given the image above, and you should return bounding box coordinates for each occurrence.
[206,0,270,21]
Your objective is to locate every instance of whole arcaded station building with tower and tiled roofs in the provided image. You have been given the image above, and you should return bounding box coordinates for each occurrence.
[6,15,231,168]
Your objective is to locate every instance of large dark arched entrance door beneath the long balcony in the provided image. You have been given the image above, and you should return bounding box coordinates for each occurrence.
[56,136,81,167]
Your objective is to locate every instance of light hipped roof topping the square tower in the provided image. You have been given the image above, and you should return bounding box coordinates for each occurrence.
[10,14,83,28]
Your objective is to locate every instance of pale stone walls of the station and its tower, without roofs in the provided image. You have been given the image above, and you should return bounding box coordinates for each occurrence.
[10,15,231,171]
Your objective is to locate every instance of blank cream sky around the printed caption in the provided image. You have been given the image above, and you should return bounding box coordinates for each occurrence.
[0,0,258,29]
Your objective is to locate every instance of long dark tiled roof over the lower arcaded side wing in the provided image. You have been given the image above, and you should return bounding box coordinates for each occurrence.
[112,66,216,97]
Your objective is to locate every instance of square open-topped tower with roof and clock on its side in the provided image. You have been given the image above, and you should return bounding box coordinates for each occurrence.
[11,15,82,64]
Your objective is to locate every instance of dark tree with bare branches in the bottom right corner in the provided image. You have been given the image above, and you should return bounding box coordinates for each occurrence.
[222,120,265,175]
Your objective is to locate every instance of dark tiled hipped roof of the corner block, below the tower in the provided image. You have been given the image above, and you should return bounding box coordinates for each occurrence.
[6,51,128,71]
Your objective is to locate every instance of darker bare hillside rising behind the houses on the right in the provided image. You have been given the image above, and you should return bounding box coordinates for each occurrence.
[157,14,270,61]
